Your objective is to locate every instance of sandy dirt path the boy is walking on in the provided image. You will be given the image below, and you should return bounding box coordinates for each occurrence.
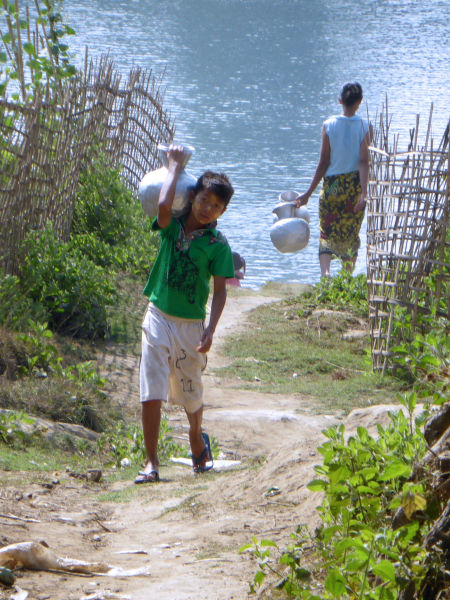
[0,291,394,600]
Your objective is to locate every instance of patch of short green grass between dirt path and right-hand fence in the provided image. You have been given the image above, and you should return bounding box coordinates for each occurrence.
[215,293,400,413]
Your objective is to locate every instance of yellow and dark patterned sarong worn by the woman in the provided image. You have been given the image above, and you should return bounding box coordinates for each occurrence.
[319,171,364,261]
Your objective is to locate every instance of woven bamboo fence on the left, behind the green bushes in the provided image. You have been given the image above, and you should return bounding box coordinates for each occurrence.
[0,57,174,274]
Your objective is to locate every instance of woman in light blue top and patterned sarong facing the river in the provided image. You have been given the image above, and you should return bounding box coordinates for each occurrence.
[297,82,371,277]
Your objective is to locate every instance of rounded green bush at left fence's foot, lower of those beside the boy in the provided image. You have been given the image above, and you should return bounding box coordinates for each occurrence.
[21,224,117,339]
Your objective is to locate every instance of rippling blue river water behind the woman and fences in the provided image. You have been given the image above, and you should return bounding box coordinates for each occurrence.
[64,0,450,289]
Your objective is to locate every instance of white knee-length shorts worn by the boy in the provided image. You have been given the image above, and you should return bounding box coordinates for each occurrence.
[139,303,207,413]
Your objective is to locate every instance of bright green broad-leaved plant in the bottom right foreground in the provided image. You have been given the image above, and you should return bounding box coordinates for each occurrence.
[241,394,442,600]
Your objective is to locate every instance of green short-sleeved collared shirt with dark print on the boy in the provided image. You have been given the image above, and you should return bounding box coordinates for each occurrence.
[144,218,234,319]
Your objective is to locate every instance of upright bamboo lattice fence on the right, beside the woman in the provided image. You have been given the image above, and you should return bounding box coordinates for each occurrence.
[367,103,450,374]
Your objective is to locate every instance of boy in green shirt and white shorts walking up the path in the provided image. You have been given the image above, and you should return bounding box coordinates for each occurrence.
[135,146,234,483]
